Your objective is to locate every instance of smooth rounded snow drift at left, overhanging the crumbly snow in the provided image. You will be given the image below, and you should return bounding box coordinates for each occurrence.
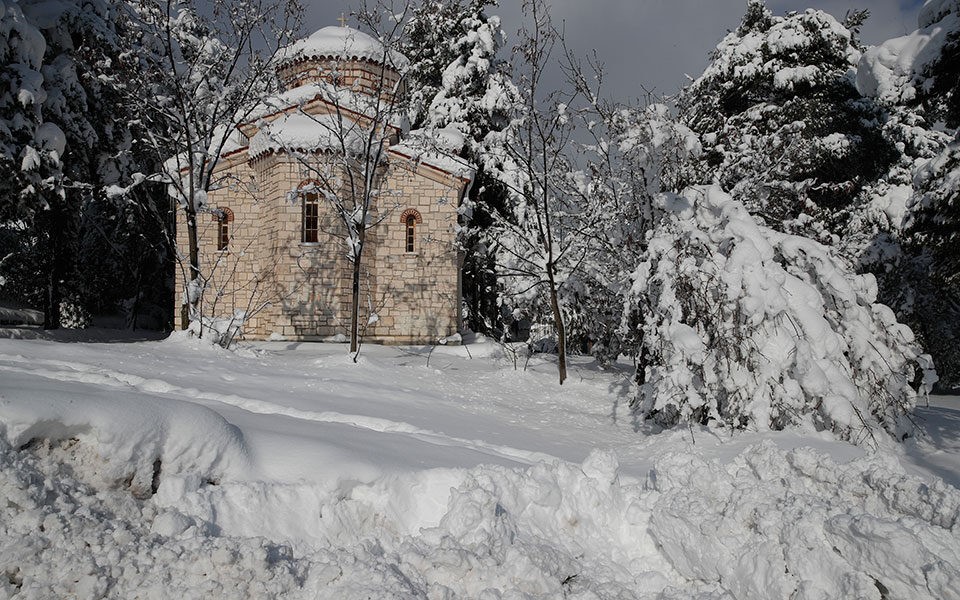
[0,372,249,497]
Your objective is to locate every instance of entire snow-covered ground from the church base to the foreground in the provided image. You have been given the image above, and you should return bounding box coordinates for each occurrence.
[0,330,960,600]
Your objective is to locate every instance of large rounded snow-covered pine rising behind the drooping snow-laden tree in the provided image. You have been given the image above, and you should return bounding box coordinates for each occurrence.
[680,0,897,243]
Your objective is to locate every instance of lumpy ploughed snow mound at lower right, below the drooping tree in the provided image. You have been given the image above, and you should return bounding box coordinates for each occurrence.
[650,442,960,600]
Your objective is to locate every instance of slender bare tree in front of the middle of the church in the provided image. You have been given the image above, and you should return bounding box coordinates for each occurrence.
[265,2,410,359]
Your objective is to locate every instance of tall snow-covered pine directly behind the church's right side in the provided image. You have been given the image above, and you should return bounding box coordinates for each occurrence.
[403,0,520,333]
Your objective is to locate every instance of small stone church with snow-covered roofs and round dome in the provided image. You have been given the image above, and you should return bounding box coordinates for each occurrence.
[176,27,473,344]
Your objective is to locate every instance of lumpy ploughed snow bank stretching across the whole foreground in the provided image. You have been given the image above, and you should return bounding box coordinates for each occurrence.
[0,428,960,600]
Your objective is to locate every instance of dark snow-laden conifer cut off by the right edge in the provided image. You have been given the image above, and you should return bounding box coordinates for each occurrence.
[857,0,960,386]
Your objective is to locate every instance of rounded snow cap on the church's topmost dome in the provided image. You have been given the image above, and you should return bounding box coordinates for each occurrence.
[277,27,409,69]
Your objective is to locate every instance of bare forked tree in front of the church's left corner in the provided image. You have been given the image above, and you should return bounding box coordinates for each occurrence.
[124,0,302,335]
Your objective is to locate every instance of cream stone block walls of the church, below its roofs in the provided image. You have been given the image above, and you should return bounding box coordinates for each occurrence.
[177,137,466,343]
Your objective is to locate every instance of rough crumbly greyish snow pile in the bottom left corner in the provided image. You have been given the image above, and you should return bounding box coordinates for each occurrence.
[0,436,306,600]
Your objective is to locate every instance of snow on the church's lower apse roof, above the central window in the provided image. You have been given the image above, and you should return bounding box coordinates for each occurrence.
[249,113,364,158]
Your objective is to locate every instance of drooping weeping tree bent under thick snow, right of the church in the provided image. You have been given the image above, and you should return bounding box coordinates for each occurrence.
[625,187,936,442]
